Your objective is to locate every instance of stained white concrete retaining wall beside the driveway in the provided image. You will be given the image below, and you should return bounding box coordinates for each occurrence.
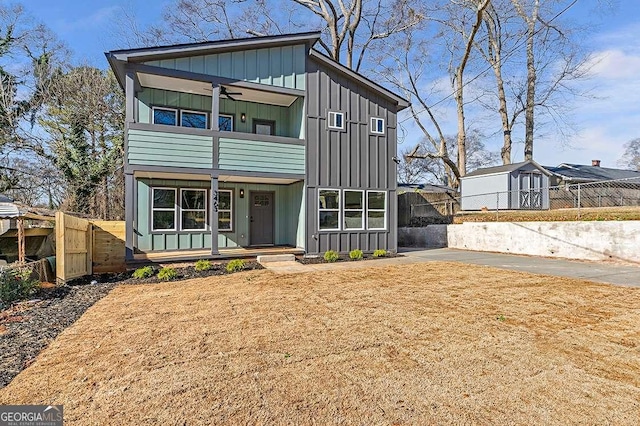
[447,221,640,262]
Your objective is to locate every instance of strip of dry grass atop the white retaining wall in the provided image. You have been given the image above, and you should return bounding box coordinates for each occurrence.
[453,207,640,223]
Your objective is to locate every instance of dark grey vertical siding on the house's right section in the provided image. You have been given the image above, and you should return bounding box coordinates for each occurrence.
[306,58,397,255]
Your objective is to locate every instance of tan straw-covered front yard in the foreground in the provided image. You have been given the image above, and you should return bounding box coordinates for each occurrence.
[0,262,640,425]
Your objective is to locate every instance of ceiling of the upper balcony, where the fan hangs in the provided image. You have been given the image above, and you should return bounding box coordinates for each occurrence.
[137,72,297,107]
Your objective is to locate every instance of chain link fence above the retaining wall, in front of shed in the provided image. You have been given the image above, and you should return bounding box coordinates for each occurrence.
[399,177,640,226]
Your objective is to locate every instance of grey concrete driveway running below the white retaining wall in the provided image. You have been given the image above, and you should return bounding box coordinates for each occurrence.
[399,248,640,287]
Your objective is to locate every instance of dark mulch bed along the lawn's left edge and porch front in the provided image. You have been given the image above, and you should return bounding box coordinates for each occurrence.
[0,262,263,388]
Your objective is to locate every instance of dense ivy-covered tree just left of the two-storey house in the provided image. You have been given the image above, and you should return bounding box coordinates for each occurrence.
[39,66,124,219]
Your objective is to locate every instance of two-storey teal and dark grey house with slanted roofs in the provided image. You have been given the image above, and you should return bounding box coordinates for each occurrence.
[106,32,408,259]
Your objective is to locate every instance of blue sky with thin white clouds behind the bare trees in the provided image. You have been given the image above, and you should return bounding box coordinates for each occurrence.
[23,0,640,167]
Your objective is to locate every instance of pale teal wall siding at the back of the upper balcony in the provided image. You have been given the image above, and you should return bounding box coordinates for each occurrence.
[138,89,304,139]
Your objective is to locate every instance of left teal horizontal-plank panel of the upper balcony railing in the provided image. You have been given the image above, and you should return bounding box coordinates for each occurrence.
[127,130,213,169]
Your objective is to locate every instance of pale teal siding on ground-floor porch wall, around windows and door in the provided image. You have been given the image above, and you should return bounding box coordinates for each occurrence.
[135,179,304,252]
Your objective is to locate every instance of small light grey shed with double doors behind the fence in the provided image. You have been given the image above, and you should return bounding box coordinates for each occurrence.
[460,160,551,210]
